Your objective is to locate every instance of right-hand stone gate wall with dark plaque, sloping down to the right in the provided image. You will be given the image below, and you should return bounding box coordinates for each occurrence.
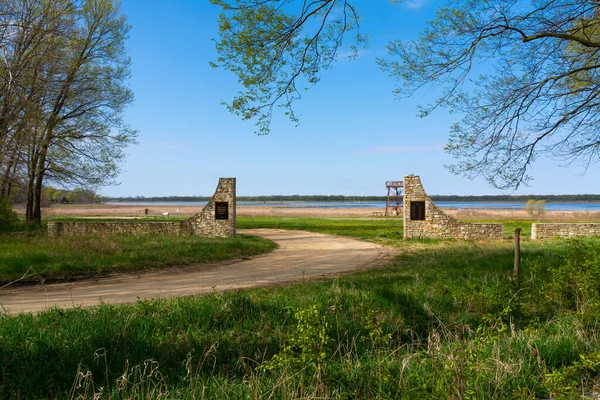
[404,175,504,239]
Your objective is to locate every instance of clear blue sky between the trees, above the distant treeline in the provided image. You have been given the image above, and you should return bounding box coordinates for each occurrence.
[105,0,600,197]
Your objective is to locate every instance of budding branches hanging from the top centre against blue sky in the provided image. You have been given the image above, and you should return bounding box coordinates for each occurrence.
[210,0,365,134]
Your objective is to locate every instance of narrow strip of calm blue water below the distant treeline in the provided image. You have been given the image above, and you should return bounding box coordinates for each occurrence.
[107,201,600,211]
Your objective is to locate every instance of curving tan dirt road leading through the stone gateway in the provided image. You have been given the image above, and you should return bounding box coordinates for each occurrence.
[0,229,393,313]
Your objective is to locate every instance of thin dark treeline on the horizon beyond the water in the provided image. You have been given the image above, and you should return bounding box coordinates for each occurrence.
[103,194,600,203]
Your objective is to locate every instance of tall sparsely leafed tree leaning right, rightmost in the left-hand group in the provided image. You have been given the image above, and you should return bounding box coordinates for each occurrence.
[32,0,135,221]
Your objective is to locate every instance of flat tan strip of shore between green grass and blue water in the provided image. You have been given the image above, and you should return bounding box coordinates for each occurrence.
[15,204,600,222]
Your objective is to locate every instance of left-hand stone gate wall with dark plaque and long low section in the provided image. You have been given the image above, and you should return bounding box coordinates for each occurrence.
[48,178,236,237]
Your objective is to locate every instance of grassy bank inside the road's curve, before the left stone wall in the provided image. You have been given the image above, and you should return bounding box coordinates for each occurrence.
[0,223,275,283]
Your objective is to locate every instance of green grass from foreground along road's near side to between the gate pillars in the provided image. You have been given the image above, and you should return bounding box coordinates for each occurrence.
[0,218,600,399]
